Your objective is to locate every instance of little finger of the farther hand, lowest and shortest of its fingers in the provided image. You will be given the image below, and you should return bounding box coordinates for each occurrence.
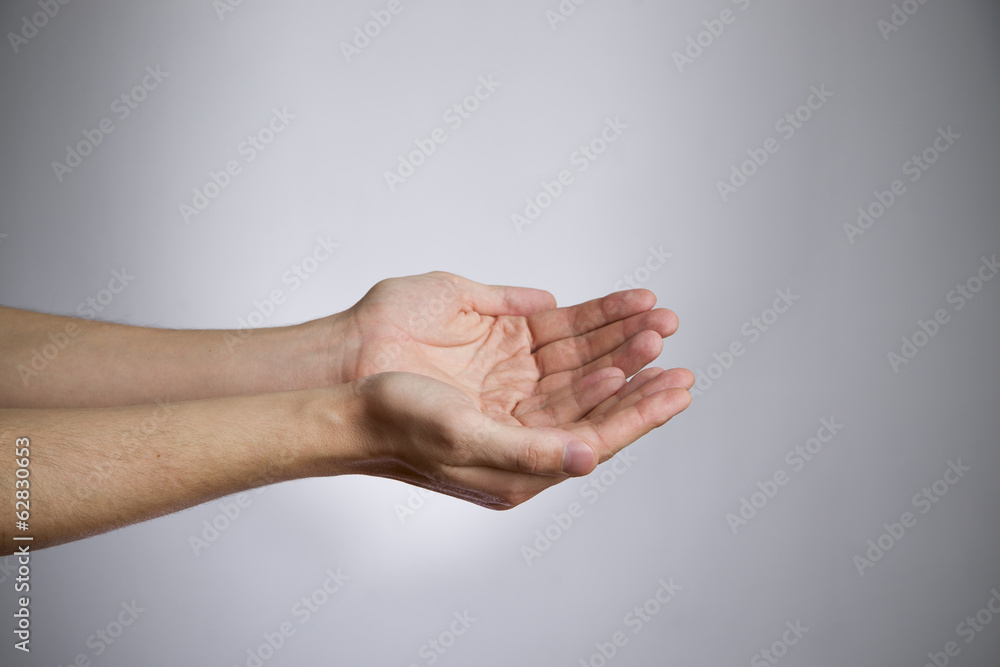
[514,366,626,426]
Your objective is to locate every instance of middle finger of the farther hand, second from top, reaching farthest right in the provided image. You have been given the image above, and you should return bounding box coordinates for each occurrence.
[534,308,678,377]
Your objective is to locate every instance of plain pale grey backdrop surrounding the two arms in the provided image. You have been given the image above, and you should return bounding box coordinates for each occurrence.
[0,0,1000,667]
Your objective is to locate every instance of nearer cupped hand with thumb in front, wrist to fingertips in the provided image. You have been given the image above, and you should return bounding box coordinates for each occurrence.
[353,369,691,509]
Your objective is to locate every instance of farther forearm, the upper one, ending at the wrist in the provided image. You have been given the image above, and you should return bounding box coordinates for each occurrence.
[0,307,338,408]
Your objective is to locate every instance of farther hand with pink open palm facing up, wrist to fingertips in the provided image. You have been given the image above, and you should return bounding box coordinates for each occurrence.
[329,272,693,434]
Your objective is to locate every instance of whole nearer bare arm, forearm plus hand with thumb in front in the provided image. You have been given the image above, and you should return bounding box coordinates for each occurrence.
[0,369,691,554]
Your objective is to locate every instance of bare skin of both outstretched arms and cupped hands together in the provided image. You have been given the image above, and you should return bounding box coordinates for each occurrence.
[0,272,694,554]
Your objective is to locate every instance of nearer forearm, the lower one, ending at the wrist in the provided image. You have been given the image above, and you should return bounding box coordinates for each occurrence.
[0,385,359,554]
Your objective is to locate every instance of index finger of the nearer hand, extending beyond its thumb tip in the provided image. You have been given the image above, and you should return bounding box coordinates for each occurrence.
[569,387,691,461]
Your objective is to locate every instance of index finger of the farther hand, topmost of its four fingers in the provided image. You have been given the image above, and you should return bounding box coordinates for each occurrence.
[528,289,656,349]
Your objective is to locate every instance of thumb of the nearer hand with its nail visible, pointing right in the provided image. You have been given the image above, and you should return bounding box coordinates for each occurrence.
[482,422,598,477]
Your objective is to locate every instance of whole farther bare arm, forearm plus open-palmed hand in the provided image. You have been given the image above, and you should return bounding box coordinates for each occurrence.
[0,272,677,412]
